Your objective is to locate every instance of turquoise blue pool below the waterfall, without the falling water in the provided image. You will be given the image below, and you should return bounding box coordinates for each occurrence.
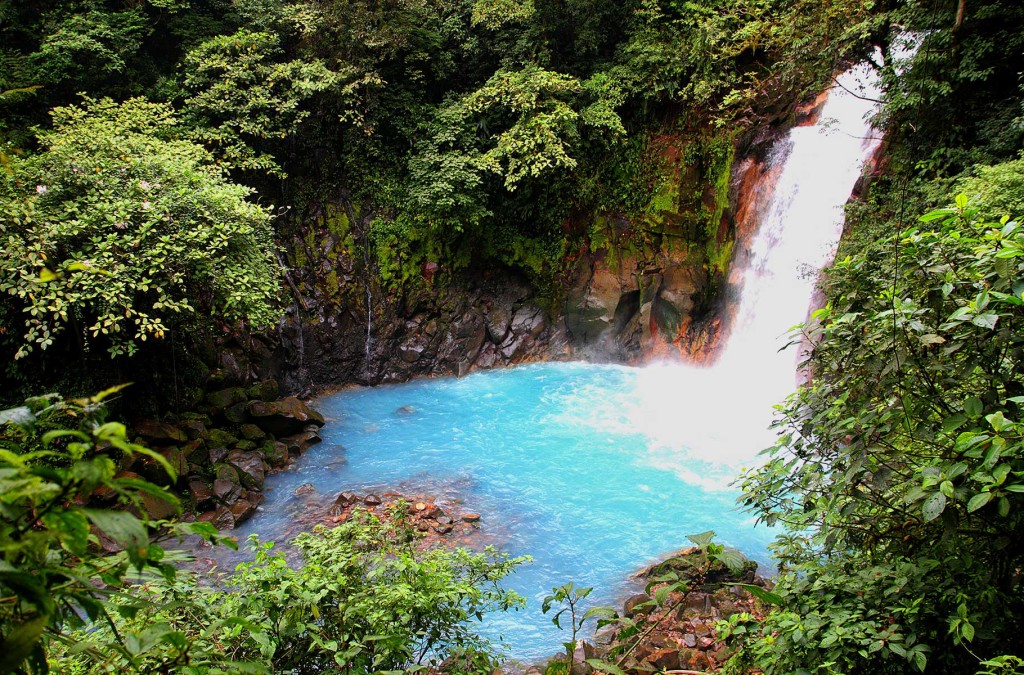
[220,364,771,661]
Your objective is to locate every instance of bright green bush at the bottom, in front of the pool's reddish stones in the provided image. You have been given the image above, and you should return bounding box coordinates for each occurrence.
[62,509,523,673]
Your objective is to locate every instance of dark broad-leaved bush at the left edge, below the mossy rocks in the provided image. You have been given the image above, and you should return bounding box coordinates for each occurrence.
[0,389,226,673]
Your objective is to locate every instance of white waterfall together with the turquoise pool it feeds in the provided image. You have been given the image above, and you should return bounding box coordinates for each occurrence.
[224,60,878,661]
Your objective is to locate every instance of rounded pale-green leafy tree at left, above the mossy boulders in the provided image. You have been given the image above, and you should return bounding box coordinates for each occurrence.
[0,98,279,356]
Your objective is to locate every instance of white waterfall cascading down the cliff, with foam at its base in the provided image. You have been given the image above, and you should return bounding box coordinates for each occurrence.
[629,65,881,489]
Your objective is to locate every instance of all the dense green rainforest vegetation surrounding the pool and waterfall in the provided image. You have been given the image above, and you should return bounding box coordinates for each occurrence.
[0,0,1024,673]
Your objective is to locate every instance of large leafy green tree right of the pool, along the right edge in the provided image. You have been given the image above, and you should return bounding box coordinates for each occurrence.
[729,186,1024,673]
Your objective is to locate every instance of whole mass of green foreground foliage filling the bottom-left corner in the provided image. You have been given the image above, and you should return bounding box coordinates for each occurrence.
[0,390,524,673]
